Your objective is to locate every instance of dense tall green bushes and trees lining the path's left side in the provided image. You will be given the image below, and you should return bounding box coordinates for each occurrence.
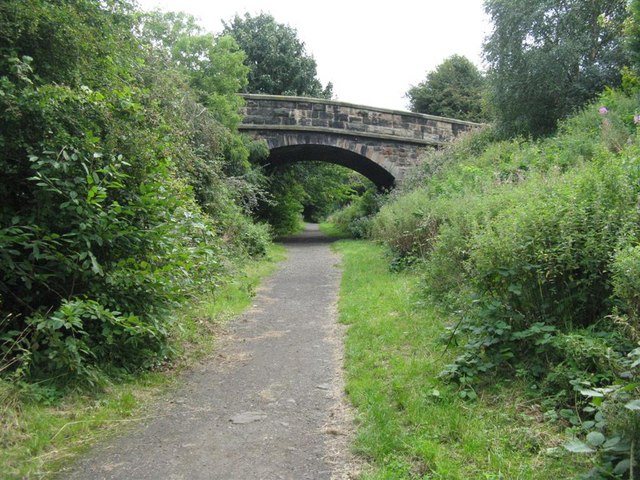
[0,0,269,387]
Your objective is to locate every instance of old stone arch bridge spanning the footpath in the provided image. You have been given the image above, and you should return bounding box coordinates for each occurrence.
[240,95,480,189]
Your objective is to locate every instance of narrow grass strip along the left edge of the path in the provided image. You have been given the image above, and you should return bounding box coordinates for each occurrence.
[0,245,285,480]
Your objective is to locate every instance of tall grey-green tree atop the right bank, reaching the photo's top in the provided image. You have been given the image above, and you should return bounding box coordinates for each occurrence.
[484,0,627,136]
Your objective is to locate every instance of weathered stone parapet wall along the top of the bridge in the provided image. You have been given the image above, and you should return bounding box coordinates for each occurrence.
[240,94,479,146]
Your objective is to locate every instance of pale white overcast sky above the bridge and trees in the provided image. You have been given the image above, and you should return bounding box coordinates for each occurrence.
[138,0,490,110]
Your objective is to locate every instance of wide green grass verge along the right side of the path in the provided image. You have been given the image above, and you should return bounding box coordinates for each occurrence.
[336,241,587,480]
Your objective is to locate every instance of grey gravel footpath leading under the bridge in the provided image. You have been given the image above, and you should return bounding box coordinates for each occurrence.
[62,225,355,480]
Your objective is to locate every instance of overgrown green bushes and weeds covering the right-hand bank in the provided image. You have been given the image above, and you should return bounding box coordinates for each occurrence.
[373,90,640,478]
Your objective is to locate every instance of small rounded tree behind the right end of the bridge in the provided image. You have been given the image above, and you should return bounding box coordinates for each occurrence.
[407,55,485,122]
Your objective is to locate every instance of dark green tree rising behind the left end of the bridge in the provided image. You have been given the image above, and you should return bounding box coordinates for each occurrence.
[223,13,333,98]
